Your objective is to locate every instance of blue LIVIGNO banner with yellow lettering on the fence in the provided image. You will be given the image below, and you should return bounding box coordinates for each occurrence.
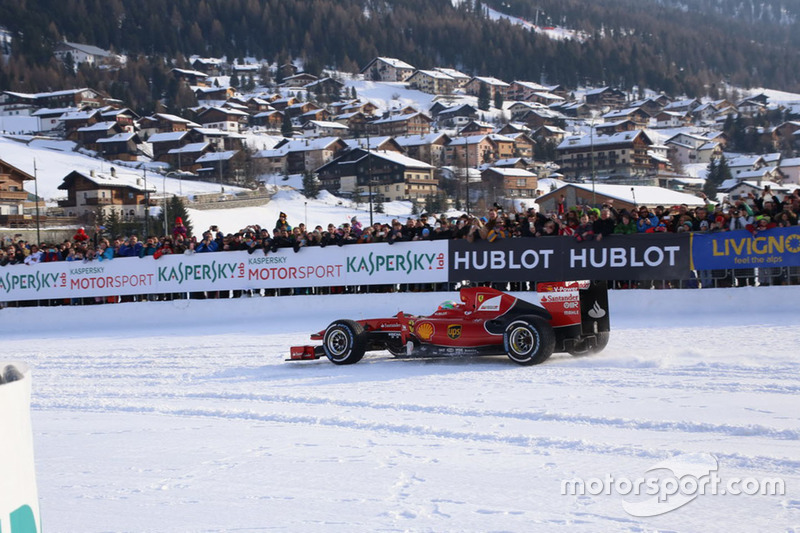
[692,226,800,270]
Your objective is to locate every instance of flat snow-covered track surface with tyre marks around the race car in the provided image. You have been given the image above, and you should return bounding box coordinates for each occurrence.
[0,287,800,532]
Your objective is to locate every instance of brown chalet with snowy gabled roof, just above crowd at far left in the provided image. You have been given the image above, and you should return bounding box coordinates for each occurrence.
[58,167,156,221]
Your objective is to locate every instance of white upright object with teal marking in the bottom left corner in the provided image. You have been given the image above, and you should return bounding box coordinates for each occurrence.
[0,361,41,533]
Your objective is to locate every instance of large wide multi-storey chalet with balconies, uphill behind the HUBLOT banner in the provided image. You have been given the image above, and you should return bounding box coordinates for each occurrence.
[556,130,653,179]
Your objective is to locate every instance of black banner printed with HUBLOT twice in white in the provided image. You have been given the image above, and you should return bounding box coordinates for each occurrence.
[449,233,690,281]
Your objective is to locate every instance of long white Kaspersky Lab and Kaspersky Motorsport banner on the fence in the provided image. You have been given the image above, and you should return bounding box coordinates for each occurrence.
[0,241,448,301]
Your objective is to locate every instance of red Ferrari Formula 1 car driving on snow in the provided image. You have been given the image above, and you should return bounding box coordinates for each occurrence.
[287,281,610,365]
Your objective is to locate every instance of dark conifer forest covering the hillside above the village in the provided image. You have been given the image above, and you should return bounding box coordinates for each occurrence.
[0,0,800,110]
